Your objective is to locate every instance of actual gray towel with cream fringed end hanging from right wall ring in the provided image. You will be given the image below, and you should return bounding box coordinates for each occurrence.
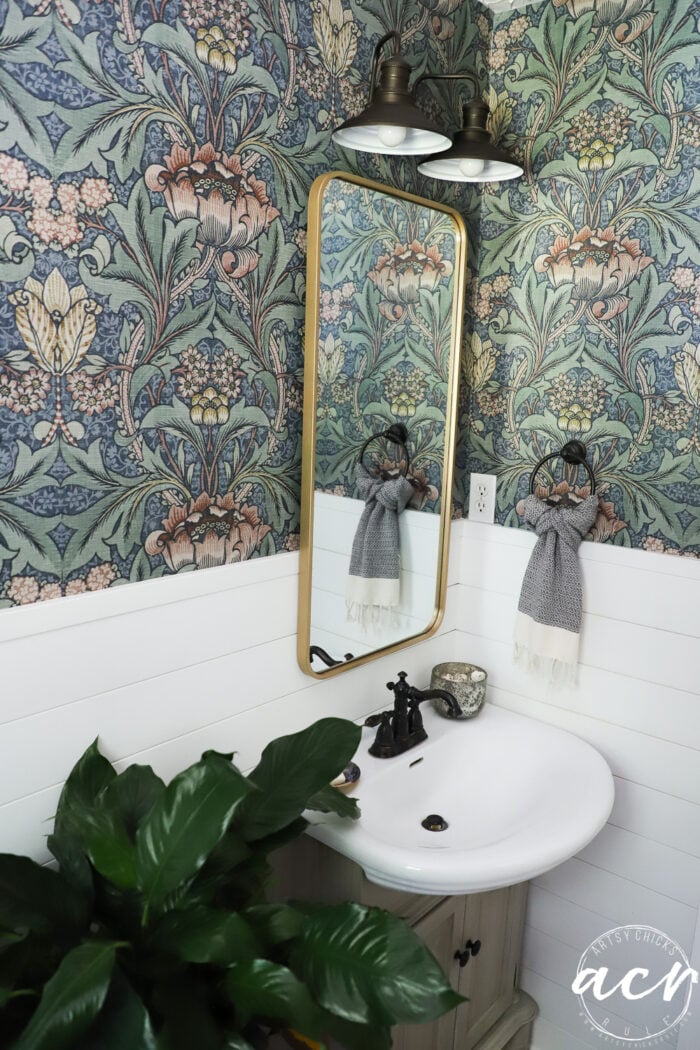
[515,496,598,681]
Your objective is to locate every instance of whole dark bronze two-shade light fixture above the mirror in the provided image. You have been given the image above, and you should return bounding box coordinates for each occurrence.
[333,32,523,183]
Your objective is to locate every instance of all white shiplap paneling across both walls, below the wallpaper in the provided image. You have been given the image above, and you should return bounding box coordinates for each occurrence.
[0,522,700,1050]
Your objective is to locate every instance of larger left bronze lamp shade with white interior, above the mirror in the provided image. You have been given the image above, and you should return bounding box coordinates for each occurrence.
[333,32,452,155]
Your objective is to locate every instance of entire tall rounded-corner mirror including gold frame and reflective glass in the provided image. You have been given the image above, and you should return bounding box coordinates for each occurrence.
[297,171,467,678]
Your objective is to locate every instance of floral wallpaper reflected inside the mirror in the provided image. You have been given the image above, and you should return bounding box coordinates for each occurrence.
[316,179,458,512]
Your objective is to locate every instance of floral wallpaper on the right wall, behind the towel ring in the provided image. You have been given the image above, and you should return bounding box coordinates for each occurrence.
[458,0,700,557]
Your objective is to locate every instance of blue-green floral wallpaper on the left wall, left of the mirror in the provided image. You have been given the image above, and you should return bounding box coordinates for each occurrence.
[0,0,483,607]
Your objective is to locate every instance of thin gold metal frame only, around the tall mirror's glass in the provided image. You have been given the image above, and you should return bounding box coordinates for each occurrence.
[297,171,467,680]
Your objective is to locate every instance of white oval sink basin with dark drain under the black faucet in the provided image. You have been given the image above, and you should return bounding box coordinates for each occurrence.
[306,704,614,896]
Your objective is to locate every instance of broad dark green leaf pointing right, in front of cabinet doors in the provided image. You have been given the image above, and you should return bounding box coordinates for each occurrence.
[291,904,464,1027]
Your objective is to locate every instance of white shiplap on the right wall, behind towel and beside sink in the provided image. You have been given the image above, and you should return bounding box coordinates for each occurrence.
[455,523,700,1050]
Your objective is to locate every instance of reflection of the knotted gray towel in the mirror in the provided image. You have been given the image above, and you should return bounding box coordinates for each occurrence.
[345,463,413,627]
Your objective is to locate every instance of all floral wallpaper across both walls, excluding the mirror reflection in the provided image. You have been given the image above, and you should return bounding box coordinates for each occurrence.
[0,0,700,606]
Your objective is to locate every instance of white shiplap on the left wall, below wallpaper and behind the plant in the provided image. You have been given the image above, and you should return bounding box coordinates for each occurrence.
[0,533,460,860]
